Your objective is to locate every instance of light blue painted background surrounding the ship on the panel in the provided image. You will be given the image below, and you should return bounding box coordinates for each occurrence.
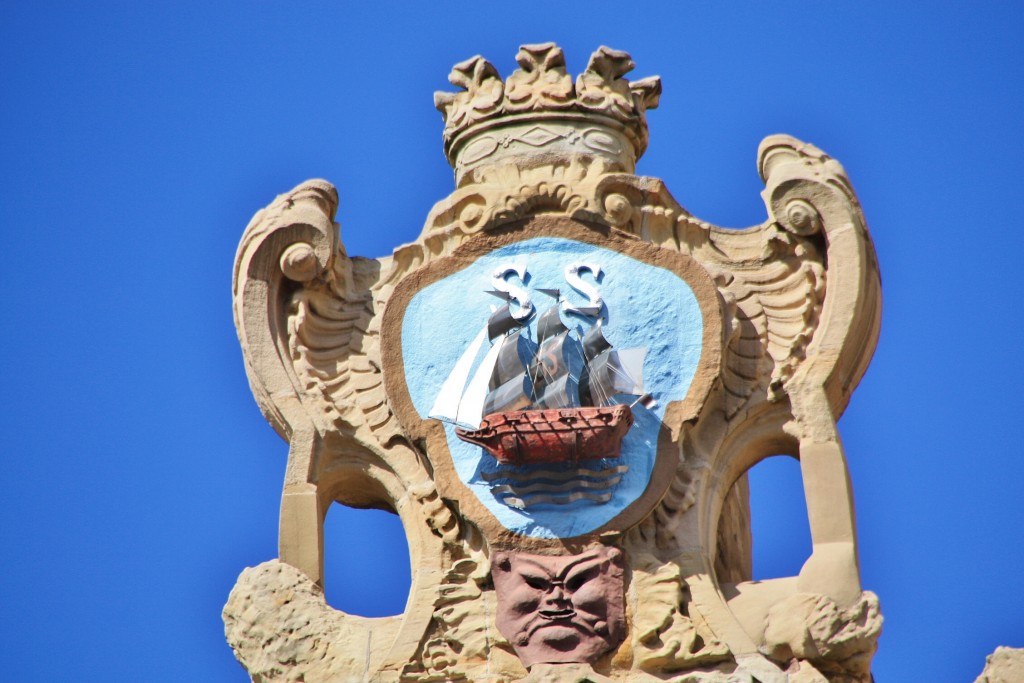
[387,227,717,540]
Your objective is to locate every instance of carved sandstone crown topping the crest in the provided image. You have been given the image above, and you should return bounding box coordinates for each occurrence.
[434,43,662,181]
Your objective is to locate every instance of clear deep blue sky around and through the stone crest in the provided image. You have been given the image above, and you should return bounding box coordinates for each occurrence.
[0,1,1024,683]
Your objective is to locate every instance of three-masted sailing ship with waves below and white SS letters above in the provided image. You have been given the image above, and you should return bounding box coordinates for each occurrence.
[429,262,655,509]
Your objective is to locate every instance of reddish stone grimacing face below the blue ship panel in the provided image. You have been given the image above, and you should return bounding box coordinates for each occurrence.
[492,548,626,667]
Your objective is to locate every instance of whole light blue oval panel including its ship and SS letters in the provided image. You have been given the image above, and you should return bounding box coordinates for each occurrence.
[395,235,716,540]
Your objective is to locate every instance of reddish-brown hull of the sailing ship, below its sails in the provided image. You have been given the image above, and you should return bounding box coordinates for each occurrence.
[455,403,633,465]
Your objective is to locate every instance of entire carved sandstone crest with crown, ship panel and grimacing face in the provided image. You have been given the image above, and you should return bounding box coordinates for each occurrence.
[223,43,882,683]
